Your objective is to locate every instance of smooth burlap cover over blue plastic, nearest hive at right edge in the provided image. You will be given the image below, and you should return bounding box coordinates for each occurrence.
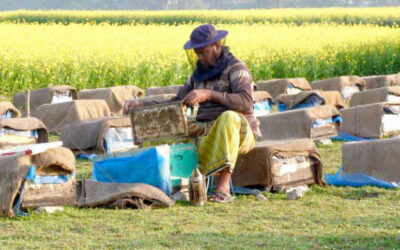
[342,138,400,183]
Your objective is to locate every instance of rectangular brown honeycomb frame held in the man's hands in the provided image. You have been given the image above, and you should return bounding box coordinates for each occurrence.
[131,102,188,143]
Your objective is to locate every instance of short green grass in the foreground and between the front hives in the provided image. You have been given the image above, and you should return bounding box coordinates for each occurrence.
[0,143,400,249]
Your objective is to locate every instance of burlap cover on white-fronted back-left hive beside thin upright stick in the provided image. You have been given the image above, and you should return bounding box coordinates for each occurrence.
[13,85,78,116]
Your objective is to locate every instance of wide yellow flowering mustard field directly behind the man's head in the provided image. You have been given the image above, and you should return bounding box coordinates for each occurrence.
[0,23,400,96]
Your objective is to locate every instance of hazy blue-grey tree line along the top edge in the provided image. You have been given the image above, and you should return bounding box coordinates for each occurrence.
[0,0,400,10]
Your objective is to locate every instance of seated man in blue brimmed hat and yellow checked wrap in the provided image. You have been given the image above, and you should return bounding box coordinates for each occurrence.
[124,24,257,203]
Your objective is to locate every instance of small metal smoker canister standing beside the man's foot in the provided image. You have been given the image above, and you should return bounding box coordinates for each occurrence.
[189,168,207,206]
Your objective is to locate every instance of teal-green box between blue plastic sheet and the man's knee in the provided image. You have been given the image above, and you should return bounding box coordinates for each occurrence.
[170,143,199,187]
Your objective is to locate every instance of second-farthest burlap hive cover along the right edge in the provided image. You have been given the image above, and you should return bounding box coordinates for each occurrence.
[350,87,400,107]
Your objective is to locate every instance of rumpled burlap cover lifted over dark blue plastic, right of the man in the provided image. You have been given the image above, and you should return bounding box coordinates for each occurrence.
[275,90,346,110]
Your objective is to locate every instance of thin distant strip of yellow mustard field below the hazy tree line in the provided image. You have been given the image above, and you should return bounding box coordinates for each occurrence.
[0,7,400,25]
